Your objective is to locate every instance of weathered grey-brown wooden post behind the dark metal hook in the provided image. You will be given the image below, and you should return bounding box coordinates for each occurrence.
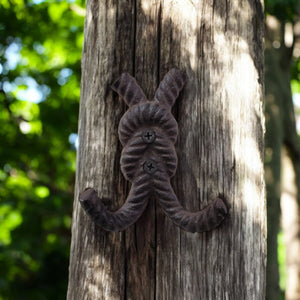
[68,0,266,300]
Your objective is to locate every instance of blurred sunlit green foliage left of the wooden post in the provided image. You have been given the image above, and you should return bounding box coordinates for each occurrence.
[0,0,84,299]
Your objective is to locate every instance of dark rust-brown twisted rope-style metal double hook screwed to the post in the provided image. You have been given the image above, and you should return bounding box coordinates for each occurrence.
[79,69,229,232]
